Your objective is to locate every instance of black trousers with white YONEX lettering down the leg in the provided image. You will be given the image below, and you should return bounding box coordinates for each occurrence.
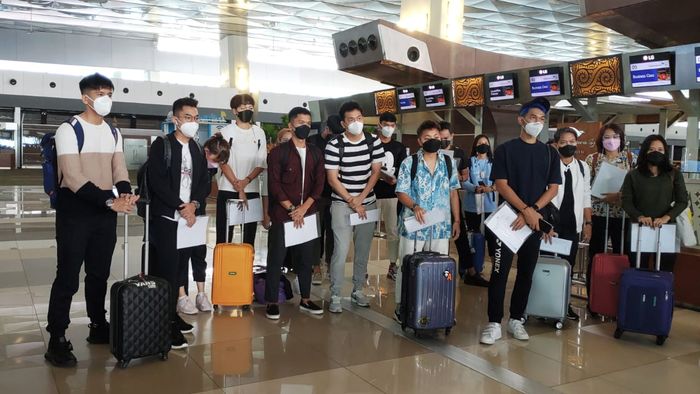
[488,233,540,323]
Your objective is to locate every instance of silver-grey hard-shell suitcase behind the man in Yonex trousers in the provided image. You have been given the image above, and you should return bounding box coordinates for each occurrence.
[525,256,571,330]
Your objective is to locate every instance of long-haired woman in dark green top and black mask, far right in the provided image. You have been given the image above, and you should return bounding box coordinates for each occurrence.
[622,135,688,272]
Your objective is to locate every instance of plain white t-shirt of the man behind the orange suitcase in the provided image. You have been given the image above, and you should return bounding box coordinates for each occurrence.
[218,123,267,193]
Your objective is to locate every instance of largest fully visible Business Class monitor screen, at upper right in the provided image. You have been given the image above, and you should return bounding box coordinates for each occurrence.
[630,52,675,88]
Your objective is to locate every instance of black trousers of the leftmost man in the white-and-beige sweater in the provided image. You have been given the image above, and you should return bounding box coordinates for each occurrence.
[46,208,117,337]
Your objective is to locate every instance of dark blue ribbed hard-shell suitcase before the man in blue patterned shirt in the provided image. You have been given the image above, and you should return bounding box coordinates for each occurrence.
[399,252,456,336]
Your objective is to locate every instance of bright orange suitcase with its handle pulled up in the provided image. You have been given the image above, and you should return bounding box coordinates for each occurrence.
[211,200,255,309]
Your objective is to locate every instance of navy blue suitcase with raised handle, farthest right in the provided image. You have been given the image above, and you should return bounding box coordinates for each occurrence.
[615,226,674,346]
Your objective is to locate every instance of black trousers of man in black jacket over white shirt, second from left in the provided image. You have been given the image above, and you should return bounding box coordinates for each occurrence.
[148,217,193,321]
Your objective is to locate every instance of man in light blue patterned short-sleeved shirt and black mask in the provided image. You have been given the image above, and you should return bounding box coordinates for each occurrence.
[395,120,460,318]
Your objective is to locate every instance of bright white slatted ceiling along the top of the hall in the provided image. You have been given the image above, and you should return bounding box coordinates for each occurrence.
[0,0,643,61]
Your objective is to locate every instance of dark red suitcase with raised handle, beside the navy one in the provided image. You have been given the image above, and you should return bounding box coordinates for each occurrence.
[588,206,630,317]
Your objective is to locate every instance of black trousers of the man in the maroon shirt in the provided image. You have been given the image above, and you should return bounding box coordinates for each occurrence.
[265,223,319,304]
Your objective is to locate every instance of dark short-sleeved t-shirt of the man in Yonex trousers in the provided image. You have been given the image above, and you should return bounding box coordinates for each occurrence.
[491,138,561,208]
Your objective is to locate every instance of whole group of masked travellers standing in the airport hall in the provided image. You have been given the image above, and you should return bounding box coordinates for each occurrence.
[45,74,688,366]
